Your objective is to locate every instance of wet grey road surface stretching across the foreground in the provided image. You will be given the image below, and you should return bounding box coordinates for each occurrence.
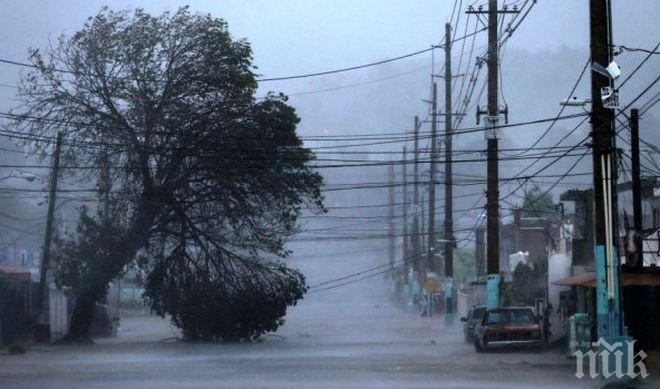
[0,301,656,389]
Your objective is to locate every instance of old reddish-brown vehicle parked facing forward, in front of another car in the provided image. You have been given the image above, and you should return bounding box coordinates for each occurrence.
[474,307,543,352]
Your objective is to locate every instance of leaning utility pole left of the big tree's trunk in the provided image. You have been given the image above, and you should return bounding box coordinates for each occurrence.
[37,132,62,341]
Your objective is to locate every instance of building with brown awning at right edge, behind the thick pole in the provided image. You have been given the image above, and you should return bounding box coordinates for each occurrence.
[549,181,660,350]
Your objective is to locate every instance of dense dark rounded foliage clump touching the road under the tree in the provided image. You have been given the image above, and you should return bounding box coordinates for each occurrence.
[145,256,307,341]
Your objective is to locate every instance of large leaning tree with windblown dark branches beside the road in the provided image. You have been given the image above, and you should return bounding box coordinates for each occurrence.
[14,8,323,339]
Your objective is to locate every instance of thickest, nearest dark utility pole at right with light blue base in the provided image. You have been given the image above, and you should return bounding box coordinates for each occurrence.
[589,0,626,342]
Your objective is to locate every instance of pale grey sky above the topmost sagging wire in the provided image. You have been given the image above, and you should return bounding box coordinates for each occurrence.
[0,0,660,94]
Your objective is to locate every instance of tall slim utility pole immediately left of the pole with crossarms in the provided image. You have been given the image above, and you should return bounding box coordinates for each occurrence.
[444,23,454,327]
